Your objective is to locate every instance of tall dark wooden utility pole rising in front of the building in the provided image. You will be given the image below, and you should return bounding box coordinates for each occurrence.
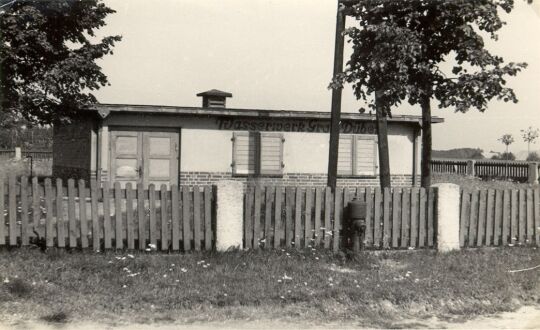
[327,1,345,192]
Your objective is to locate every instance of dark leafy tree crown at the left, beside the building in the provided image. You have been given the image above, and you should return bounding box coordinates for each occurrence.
[0,0,121,127]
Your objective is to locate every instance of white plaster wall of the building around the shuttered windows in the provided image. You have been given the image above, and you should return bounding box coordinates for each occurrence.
[106,114,419,175]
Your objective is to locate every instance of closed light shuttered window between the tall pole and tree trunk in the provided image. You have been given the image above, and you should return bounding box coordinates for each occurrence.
[338,134,377,176]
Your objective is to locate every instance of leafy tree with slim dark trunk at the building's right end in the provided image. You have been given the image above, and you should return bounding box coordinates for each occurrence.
[335,0,526,187]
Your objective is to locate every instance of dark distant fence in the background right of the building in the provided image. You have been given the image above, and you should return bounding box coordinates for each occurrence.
[431,159,540,183]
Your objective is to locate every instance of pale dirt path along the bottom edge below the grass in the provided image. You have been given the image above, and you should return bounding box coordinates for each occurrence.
[0,306,540,330]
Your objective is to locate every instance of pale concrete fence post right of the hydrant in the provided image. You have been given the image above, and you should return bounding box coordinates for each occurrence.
[433,183,460,252]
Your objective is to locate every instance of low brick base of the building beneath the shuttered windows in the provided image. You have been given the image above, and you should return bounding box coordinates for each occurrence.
[180,172,419,187]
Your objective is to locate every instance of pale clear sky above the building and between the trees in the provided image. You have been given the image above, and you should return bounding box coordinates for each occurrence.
[95,0,540,157]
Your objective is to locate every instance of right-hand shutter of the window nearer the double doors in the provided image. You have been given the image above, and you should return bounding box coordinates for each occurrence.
[260,132,284,175]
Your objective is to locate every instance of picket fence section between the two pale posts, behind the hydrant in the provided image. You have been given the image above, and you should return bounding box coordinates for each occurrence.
[244,186,437,251]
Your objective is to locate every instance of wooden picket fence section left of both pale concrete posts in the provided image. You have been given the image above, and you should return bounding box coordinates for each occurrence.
[0,177,215,251]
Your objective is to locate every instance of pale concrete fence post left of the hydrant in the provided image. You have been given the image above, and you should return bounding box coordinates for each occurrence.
[216,180,244,251]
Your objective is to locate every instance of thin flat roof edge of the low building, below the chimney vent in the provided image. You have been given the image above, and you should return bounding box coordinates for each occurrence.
[92,103,444,123]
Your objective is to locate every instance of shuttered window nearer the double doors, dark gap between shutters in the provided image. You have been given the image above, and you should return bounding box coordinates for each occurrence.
[232,132,284,175]
